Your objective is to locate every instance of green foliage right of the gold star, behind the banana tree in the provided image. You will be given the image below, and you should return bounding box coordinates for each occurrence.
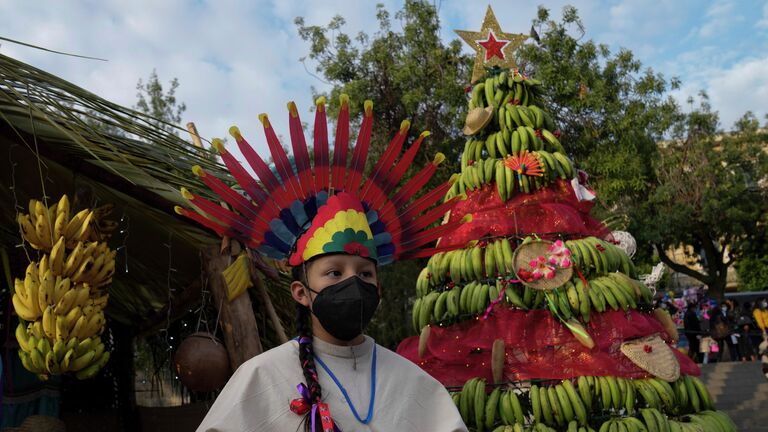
[518,6,679,209]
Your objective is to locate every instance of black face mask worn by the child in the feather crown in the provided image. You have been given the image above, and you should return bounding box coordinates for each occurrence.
[307,276,379,341]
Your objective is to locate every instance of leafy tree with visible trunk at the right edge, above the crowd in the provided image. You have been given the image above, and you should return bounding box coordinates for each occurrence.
[636,99,768,298]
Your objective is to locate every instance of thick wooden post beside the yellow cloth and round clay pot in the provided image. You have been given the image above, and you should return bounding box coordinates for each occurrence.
[204,246,263,371]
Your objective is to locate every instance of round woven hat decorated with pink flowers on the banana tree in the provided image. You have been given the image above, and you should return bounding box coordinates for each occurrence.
[512,240,573,290]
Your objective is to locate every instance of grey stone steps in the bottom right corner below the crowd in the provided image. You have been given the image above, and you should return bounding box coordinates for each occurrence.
[701,362,768,432]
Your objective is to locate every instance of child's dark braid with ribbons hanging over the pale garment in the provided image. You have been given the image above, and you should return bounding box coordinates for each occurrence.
[291,264,323,432]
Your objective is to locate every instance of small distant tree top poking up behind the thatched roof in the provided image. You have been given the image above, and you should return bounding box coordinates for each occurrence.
[134,69,187,135]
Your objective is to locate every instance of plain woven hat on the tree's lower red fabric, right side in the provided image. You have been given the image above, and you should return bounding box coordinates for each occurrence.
[621,335,680,382]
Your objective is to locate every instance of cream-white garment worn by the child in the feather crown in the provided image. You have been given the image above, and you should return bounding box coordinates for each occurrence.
[197,336,467,432]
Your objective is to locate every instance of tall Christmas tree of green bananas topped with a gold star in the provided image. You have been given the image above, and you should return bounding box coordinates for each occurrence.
[398,7,735,431]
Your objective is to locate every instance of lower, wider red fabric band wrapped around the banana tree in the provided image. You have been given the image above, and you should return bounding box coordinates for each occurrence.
[397,305,700,387]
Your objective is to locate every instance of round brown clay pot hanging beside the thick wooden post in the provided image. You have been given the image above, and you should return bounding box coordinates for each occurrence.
[173,332,231,392]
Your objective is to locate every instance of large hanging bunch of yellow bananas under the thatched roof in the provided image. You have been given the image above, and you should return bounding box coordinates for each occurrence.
[11,195,116,379]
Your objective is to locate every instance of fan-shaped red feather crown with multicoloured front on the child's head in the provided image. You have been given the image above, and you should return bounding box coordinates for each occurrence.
[176,95,471,266]
